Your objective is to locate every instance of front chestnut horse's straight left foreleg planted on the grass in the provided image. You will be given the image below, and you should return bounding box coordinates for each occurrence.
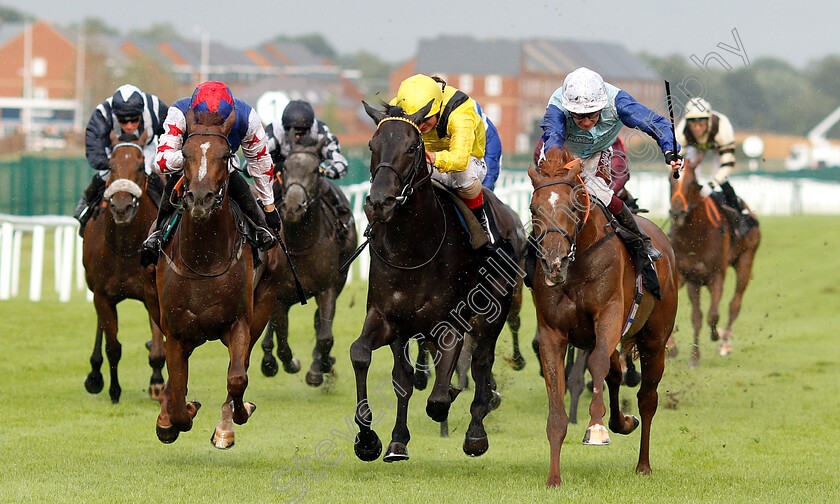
[535,324,572,487]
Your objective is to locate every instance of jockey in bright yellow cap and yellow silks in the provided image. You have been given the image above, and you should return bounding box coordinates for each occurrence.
[391,74,501,245]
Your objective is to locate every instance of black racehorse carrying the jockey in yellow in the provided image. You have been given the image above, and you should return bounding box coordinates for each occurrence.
[350,102,522,462]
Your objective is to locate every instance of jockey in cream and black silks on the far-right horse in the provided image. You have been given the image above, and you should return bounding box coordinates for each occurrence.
[676,98,753,236]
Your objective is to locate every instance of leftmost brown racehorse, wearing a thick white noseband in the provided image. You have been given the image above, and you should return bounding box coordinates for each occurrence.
[82,132,165,403]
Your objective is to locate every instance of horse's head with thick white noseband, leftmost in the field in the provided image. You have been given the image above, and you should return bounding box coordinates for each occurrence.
[104,130,149,226]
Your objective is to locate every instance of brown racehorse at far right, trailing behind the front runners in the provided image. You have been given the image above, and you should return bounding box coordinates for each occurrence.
[669,163,761,367]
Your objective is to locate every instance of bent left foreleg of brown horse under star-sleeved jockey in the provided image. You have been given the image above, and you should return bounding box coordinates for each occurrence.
[157,335,201,443]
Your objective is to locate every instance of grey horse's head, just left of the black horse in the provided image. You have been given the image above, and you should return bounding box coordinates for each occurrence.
[280,134,327,223]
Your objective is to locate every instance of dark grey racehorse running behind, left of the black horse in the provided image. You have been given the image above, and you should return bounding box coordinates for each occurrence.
[262,135,358,387]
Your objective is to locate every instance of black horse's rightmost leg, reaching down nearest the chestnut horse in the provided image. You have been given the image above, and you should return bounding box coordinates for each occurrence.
[464,324,498,457]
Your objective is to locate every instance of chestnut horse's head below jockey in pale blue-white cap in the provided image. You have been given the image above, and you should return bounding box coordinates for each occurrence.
[528,148,593,286]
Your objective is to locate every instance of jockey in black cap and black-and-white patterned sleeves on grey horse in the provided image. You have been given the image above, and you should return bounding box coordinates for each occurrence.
[265,100,353,238]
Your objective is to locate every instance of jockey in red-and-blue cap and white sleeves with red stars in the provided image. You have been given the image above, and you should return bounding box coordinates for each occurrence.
[143,81,282,257]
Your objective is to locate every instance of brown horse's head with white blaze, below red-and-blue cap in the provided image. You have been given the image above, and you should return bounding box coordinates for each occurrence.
[181,109,236,220]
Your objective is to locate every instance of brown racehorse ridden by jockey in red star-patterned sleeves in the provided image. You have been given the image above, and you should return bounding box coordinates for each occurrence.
[147,109,280,449]
